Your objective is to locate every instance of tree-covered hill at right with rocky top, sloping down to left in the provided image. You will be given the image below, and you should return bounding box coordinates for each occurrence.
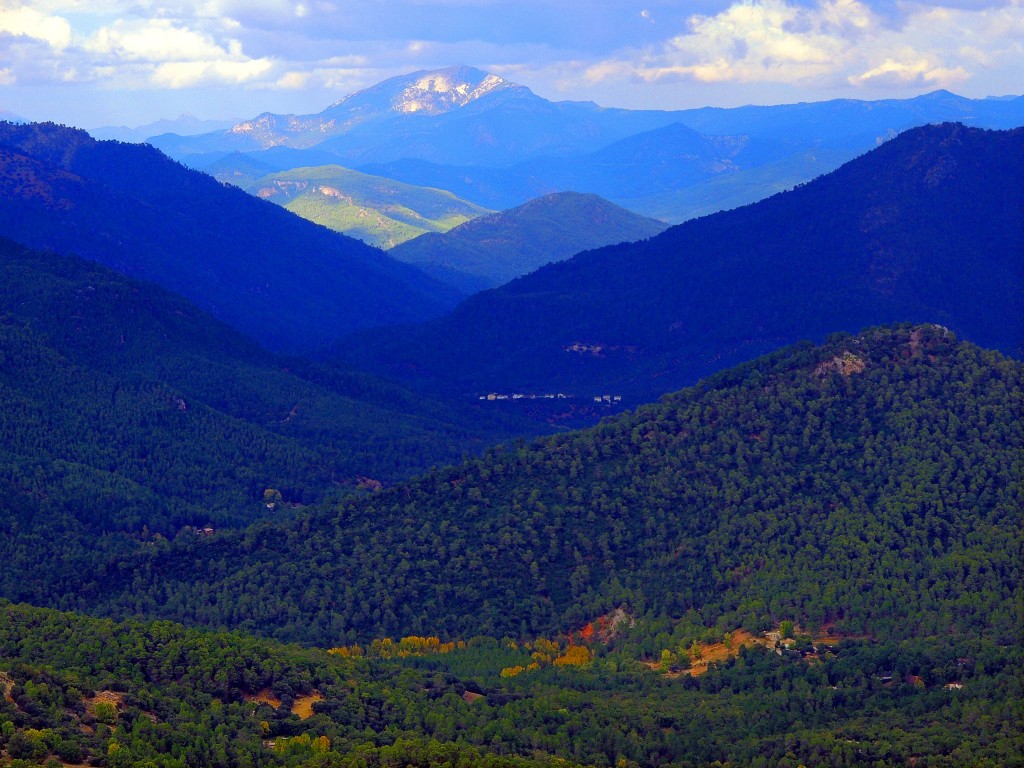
[37,327,1024,650]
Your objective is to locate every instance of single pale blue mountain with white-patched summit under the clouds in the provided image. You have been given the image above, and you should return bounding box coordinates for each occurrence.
[150,67,688,166]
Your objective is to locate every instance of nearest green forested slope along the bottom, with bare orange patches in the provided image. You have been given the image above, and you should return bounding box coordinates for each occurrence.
[0,601,1021,768]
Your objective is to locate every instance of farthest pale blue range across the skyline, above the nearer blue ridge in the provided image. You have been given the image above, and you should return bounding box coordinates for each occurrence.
[151,67,1024,173]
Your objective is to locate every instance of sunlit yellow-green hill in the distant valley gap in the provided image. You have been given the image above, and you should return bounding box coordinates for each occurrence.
[241,165,490,247]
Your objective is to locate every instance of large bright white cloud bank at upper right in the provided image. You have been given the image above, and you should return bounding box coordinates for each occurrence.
[584,0,1024,95]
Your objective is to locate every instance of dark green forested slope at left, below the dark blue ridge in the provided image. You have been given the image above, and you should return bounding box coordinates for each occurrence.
[0,240,536,610]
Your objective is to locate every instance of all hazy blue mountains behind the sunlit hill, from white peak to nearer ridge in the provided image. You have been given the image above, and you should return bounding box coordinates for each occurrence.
[151,67,1024,222]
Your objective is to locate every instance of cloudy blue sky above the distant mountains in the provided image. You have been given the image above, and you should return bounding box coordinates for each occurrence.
[0,0,1024,128]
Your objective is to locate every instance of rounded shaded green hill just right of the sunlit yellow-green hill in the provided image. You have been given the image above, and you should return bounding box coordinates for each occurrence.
[389,193,667,290]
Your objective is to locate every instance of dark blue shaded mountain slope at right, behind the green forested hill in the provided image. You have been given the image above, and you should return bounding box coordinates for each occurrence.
[345,124,1024,398]
